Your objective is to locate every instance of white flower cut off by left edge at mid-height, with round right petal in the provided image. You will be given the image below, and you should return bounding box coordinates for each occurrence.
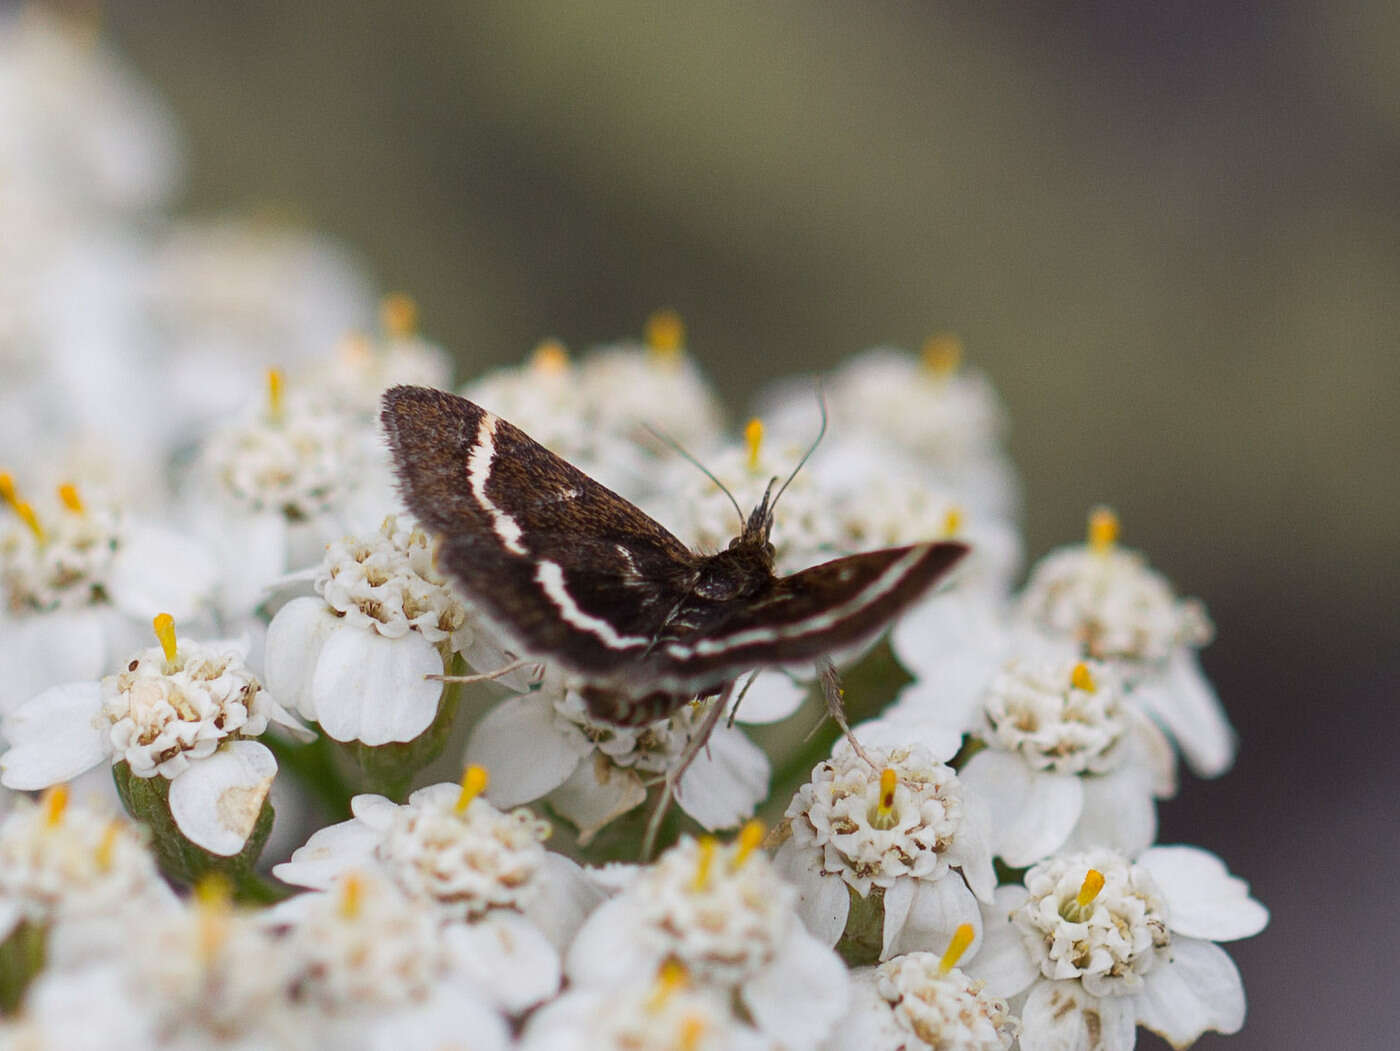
[0,473,218,712]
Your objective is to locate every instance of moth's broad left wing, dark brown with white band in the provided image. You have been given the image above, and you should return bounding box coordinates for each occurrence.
[381,386,696,676]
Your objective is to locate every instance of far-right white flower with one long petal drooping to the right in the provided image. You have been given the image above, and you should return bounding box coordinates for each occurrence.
[1019,508,1235,777]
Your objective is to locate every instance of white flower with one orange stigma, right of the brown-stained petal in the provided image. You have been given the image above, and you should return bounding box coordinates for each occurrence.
[273,767,598,968]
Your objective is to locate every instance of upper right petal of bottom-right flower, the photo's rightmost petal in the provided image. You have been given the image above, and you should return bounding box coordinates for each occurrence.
[1138,847,1268,942]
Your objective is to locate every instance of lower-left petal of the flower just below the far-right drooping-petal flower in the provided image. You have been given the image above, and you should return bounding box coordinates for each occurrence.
[958,749,1084,869]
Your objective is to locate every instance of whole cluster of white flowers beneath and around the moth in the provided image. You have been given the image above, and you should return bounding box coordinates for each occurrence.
[0,14,1267,1051]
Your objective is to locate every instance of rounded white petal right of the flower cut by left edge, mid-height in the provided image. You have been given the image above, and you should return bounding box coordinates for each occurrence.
[106,525,218,624]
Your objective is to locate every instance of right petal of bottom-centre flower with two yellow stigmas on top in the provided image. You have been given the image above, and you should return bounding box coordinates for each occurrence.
[739,924,850,1047]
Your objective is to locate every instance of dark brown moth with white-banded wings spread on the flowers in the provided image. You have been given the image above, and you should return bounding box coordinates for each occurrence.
[381,386,967,725]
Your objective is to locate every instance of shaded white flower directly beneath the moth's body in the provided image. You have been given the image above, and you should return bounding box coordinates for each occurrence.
[466,673,772,842]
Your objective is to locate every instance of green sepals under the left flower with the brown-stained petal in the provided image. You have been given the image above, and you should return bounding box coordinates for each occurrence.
[112,761,277,901]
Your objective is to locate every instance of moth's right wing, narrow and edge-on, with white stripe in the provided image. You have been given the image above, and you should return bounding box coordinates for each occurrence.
[641,542,967,693]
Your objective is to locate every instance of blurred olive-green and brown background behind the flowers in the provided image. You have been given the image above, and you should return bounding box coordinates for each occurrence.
[104,0,1400,1051]
